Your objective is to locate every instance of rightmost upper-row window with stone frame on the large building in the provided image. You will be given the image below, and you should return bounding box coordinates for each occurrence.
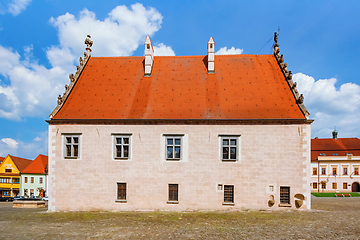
[220,135,240,161]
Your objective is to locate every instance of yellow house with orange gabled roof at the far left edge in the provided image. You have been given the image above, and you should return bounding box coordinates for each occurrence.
[0,155,32,197]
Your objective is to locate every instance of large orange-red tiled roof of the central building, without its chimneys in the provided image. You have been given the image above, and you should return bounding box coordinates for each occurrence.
[52,55,306,119]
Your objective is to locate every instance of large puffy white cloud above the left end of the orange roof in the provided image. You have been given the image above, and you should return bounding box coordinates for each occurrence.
[50,3,163,56]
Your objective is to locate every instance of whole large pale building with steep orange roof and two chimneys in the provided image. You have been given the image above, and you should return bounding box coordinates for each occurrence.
[48,36,312,211]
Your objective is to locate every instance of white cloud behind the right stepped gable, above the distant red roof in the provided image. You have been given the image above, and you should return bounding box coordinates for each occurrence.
[293,73,360,137]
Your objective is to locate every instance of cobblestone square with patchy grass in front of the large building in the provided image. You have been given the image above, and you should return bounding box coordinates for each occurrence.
[0,198,360,239]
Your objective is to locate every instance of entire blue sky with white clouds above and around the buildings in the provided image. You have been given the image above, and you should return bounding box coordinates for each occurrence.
[0,0,360,159]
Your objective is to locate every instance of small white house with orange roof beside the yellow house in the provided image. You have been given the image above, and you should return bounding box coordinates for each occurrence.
[20,154,48,197]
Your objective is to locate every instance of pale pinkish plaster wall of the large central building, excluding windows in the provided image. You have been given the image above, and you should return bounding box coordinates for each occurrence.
[49,125,311,211]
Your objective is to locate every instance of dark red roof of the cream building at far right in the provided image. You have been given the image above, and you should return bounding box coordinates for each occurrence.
[311,138,360,161]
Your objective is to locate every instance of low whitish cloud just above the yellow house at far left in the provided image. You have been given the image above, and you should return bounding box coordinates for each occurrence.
[0,132,48,159]
